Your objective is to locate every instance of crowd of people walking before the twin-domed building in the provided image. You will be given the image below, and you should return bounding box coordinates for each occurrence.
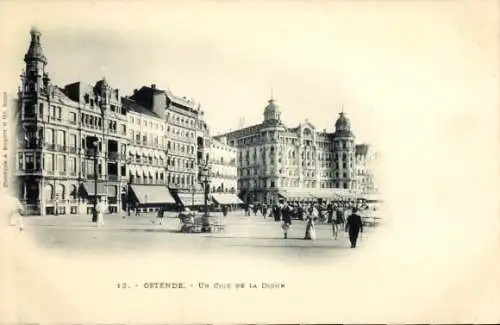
[245,201,363,248]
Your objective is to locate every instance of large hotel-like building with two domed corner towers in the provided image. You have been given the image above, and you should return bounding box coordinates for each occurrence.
[221,98,369,203]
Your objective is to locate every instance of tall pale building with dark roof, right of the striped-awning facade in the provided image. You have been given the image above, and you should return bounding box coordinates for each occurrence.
[129,84,210,206]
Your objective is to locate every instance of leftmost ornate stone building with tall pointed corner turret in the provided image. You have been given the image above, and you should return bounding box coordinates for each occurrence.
[16,29,128,215]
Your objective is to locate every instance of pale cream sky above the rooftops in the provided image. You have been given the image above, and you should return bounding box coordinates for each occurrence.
[0,1,498,182]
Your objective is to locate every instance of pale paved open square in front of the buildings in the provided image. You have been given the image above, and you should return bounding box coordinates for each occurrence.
[20,211,373,257]
